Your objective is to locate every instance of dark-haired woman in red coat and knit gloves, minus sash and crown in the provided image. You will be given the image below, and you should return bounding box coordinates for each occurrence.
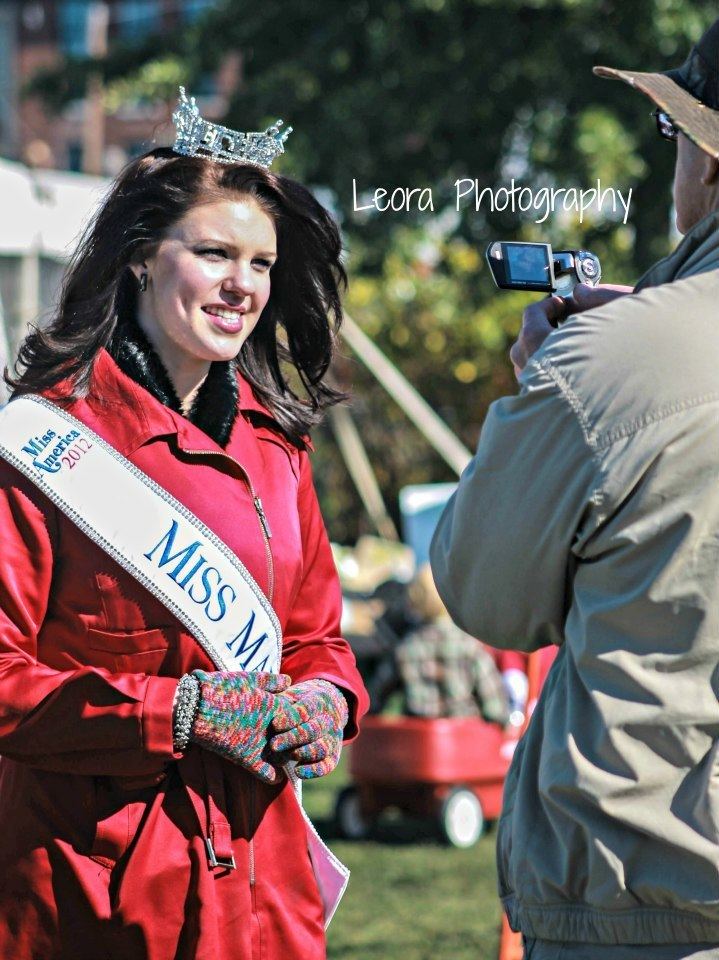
[0,139,366,960]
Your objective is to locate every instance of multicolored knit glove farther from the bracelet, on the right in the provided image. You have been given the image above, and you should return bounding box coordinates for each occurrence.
[270,680,348,780]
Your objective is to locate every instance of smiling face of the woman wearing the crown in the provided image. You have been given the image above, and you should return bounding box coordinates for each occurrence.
[132,196,277,384]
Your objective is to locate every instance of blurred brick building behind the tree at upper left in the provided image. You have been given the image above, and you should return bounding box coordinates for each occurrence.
[0,0,233,175]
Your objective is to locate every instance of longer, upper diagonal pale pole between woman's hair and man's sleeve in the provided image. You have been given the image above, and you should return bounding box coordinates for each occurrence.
[340,313,472,476]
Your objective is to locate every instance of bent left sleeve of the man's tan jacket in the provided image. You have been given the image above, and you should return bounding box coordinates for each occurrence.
[430,361,600,650]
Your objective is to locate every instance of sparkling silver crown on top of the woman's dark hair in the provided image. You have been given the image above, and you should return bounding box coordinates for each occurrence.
[172,87,292,170]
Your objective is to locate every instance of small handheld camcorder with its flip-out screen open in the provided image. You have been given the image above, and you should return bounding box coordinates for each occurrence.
[487,240,602,297]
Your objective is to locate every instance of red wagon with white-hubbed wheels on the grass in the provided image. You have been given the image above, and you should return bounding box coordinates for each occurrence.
[335,716,515,847]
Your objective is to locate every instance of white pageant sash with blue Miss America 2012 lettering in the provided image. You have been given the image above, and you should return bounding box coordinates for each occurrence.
[0,395,349,926]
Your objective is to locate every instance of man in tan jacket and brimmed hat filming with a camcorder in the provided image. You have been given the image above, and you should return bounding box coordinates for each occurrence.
[431,21,719,960]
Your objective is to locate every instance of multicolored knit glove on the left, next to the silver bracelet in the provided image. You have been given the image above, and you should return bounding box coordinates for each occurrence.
[190,670,292,783]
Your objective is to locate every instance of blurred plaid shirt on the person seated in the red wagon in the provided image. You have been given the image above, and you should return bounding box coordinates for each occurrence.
[372,619,509,724]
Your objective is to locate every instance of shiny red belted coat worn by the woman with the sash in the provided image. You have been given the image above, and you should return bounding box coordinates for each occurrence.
[0,351,367,960]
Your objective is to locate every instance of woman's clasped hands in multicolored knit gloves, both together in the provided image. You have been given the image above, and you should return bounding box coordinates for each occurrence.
[190,670,348,783]
